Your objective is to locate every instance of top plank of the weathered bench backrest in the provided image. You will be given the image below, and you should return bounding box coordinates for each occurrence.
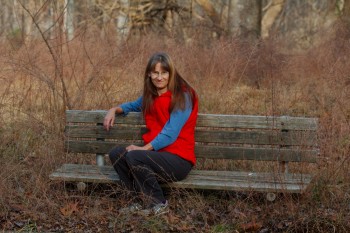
[66,110,318,130]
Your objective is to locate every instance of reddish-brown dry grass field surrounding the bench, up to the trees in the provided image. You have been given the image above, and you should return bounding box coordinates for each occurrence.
[0,21,350,232]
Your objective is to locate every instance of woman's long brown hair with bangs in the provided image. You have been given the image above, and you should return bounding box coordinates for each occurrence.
[142,52,197,114]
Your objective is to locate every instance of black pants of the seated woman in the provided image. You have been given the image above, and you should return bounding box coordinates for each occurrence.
[109,147,192,204]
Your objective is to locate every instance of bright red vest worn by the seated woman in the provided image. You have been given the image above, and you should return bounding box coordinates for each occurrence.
[142,91,198,165]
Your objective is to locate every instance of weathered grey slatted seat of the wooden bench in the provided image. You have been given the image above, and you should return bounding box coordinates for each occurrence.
[50,164,312,193]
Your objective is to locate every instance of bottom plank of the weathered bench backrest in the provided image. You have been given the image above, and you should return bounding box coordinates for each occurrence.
[65,140,319,163]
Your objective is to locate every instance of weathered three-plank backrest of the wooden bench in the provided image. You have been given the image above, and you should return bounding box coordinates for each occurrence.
[65,110,319,163]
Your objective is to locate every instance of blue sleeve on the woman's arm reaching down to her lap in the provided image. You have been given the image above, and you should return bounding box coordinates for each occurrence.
[151,95,192,151]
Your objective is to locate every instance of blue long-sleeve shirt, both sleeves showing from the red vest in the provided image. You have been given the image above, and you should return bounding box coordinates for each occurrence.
[120,94,192,151]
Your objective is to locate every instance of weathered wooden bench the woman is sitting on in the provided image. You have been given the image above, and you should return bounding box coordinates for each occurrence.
[50,110,319,199]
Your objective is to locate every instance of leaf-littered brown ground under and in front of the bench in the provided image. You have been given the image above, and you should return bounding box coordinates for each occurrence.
[0,154,350,233]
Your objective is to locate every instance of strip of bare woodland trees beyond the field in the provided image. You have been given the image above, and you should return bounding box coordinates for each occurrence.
[0,0,350,51]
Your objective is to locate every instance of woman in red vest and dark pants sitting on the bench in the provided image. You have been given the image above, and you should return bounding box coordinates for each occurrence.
[104,53,198,214]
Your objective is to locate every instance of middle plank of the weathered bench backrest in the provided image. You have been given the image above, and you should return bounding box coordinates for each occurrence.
[65,125,316,146]
